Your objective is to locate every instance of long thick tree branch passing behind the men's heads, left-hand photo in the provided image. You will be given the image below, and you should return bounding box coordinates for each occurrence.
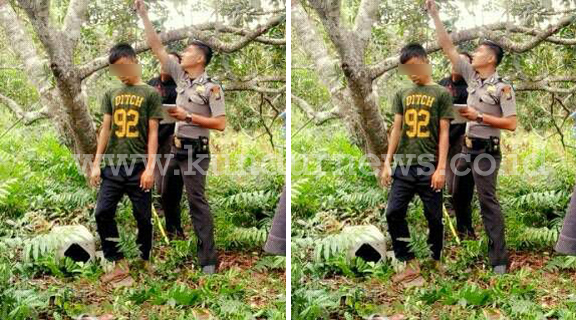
[78,15,286,79]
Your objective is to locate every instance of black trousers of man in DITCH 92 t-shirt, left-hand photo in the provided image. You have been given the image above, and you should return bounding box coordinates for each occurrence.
[95,163,152,261]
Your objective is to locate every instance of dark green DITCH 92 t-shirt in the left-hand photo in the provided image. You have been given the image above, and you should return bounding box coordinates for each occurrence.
[102,84,162,165]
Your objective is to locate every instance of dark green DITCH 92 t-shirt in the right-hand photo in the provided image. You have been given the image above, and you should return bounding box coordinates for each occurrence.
[392,84,454,166]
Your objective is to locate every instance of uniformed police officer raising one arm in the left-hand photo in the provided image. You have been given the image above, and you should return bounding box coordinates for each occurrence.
[135,0,226,274]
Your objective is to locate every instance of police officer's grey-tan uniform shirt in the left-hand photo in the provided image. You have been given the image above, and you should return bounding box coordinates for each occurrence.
[164,59,226,139]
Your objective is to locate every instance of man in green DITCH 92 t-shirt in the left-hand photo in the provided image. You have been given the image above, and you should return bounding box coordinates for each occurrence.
[90,44,162,283]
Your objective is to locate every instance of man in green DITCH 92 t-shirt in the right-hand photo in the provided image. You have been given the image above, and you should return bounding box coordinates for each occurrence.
[380,44,453,282]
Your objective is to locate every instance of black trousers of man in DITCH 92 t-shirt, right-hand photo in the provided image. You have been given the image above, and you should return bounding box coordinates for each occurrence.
[386,166,444,261]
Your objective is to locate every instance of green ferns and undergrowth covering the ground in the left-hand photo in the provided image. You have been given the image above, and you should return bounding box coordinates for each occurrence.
[0,124,286,320]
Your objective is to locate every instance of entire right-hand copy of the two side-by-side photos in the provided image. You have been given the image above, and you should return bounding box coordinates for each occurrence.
[291,0,576,320]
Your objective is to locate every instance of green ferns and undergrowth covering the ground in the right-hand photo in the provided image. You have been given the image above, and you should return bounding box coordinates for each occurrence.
[291,120,576,319]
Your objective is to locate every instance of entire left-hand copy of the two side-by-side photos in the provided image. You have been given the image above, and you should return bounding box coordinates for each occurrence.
[0,0,287,320]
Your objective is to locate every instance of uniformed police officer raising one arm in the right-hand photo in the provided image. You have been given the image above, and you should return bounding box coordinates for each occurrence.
[426,0,517,274]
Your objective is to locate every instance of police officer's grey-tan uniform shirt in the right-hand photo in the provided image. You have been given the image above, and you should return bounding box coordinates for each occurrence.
[454,58,516,139]
